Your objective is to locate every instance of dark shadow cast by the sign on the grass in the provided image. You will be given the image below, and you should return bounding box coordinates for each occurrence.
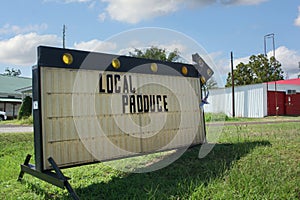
[64,141,271,199]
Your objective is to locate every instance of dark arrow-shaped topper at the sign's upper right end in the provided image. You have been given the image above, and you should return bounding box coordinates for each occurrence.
[192,53,214,84]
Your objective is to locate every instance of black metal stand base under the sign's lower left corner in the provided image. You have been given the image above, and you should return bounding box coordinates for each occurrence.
[18,154,79,200]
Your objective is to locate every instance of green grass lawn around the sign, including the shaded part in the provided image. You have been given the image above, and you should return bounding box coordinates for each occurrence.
[0,123,300,199]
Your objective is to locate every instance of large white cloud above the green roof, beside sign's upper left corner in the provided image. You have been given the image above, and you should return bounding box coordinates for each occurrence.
[0,33,59,66]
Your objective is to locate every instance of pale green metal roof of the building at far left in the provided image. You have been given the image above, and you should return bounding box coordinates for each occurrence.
[0,74,32,95]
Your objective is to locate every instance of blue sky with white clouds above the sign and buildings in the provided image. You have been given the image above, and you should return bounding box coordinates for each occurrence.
[0,0,300,85]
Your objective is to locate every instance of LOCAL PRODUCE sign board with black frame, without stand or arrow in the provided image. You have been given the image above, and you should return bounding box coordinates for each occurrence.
[33,47,205,171]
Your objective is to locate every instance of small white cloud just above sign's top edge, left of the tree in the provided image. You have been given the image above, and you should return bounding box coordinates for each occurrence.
[74,39,117,53]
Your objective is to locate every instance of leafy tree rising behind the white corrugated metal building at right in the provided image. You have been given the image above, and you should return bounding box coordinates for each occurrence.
[225,54,283,87]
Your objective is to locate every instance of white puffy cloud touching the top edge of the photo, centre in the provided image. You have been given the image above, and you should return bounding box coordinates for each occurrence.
[102,0,268,24]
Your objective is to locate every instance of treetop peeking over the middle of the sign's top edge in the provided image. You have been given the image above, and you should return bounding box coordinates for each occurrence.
[129,46,180,62]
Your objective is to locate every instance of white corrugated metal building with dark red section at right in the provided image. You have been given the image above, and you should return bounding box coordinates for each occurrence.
[204,78,300,118]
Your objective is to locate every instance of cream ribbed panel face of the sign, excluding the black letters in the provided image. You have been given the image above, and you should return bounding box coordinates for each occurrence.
[41,67,205,169]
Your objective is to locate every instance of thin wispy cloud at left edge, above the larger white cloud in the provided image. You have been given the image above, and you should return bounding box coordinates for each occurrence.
[0,23,48,35]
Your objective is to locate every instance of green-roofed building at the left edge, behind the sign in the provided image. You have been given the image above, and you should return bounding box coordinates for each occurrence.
[0,74,32,119]
